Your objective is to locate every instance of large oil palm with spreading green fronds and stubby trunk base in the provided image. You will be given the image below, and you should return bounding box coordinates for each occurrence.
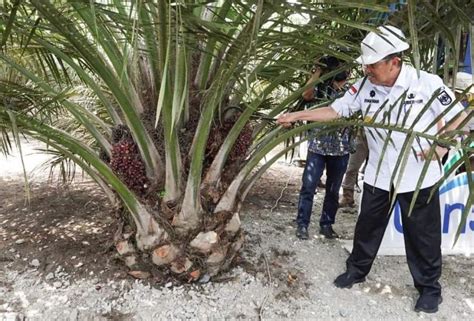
[0,0,472,280]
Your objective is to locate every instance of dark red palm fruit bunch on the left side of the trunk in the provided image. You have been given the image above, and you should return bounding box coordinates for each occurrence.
[110,139,150,196]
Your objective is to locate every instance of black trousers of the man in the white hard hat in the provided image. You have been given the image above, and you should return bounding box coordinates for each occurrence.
[346,184,441,296]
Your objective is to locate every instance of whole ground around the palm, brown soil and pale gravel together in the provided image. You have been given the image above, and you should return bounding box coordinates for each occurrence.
[0,143,474,320]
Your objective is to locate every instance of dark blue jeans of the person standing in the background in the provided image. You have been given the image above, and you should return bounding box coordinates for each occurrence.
[296,151,349,227]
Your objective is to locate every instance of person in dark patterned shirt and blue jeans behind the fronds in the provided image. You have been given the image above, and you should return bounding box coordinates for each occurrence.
[296,57,353,240]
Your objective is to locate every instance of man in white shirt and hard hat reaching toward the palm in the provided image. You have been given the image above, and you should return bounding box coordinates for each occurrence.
[278,26,466,313]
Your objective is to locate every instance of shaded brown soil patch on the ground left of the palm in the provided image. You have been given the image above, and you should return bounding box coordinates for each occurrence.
[0,180,126,281]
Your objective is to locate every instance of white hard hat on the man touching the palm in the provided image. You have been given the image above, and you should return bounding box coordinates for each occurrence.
[356,26,410,65]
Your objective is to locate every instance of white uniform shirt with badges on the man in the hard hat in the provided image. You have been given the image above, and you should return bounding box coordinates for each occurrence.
[331,64,463,193]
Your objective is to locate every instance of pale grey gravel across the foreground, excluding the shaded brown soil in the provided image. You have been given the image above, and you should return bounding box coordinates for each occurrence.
[0,141,474,320]
